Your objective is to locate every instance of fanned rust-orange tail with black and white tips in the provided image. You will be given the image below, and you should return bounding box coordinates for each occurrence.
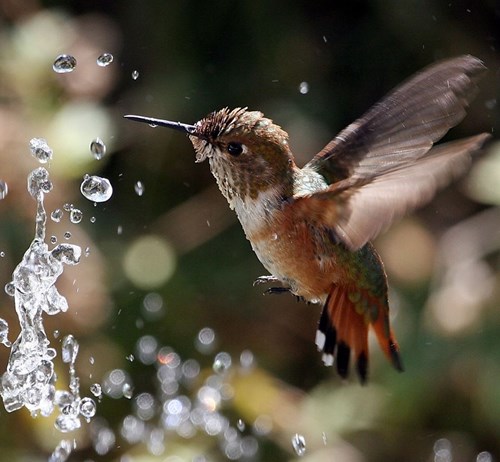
[316,286,403,383]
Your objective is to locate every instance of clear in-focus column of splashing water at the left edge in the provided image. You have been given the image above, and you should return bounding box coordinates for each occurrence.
[0,140,95,462]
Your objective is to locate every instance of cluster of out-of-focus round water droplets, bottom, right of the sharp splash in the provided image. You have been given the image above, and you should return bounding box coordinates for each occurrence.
[91,327,260,461]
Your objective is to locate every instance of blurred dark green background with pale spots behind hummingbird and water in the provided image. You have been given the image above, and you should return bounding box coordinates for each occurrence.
[0,0,500,462]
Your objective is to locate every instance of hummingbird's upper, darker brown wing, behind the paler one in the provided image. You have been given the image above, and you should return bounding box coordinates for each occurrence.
[304,56,486,184]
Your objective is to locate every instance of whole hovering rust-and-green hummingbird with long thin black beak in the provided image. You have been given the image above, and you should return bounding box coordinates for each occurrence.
[125,55,489,383]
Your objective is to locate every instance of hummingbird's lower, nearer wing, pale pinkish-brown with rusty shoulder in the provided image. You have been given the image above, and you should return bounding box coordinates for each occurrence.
[291,133,489,250]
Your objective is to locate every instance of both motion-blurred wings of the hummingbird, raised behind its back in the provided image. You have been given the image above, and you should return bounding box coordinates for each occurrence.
[294,56,489,250]
